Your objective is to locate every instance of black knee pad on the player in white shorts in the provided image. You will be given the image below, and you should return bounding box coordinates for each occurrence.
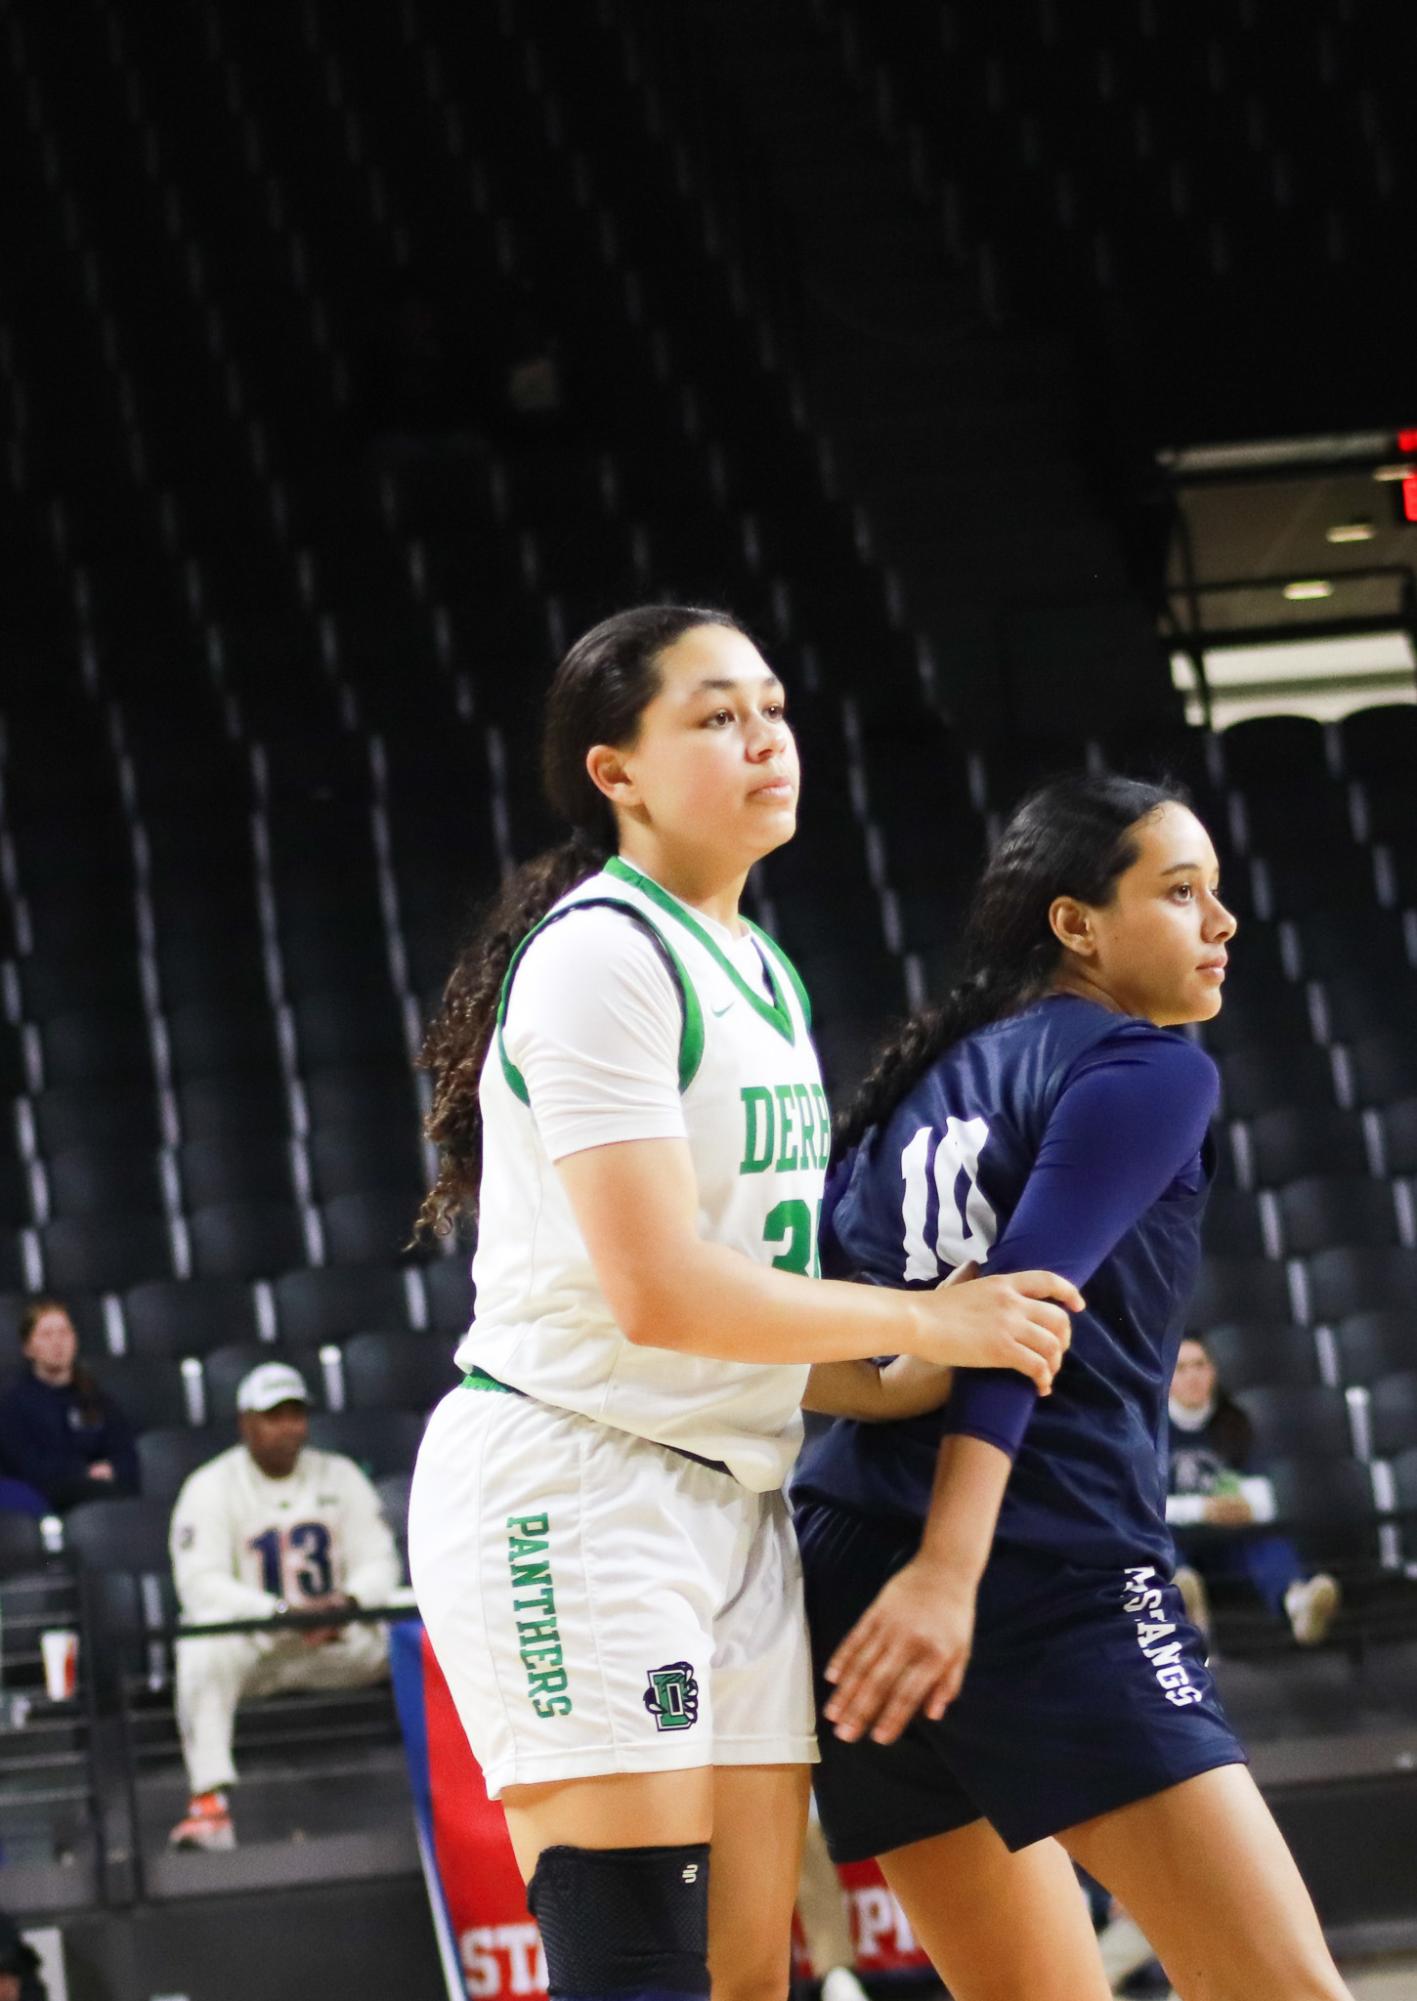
[526,1841,709,1995]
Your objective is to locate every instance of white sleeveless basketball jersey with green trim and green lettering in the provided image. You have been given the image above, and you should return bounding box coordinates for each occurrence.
[458,856,831,1491]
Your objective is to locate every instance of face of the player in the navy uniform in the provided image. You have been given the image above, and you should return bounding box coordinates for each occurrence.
[1053,804,1235,1029]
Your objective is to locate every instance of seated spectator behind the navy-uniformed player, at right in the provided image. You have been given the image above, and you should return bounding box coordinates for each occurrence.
[1167,1335,1341,1647]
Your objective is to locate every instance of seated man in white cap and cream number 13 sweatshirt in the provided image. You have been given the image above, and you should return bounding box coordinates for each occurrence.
[170,1363,400,1849]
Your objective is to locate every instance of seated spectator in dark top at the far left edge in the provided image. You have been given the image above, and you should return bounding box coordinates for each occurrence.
[0,1299,138,1511]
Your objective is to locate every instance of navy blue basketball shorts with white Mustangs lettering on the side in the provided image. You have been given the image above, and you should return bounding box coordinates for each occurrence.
[797,1501,1245,1863]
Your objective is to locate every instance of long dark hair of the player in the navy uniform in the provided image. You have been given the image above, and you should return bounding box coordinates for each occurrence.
[837,772,1189,1153]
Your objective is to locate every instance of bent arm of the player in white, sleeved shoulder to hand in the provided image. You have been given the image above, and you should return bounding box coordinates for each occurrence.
[520,910,1081,1389]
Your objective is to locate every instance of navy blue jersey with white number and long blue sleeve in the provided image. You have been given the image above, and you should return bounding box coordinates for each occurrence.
[795,994,1217,1567]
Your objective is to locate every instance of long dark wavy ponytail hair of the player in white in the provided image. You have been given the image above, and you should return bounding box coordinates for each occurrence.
[414,604,743,1237]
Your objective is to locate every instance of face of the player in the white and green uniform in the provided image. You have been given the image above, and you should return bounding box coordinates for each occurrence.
[588,626,801,870]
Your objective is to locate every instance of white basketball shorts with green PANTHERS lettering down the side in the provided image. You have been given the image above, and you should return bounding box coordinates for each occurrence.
[408,1389,817,1799]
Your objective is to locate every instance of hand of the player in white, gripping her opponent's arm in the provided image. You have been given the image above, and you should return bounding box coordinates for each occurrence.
[911,1271,1083,1397]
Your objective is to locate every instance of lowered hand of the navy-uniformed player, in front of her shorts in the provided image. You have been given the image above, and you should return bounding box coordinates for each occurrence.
[825,1555,975,1745]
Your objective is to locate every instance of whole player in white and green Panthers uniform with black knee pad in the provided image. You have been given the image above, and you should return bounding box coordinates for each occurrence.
[408,606,1081,2001]
